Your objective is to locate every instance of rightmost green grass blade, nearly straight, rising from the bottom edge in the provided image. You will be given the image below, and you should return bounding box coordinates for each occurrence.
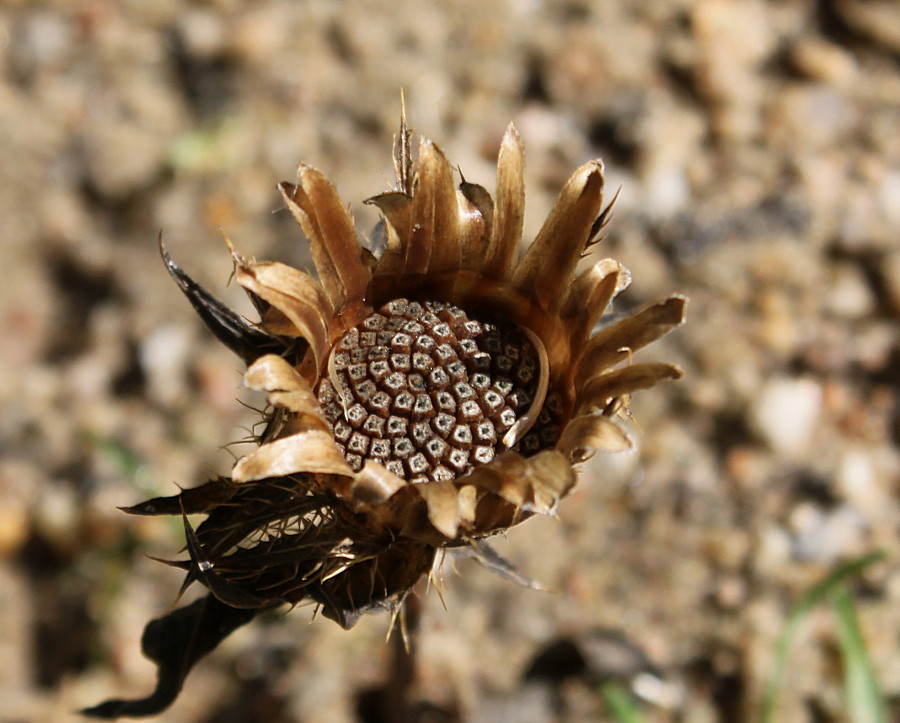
[831,585,888,723]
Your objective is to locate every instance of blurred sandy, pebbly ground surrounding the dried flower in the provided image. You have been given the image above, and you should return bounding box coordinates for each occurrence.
[0,0,900,723]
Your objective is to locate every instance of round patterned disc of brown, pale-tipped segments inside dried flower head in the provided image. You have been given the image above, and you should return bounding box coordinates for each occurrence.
[316,299,558,482]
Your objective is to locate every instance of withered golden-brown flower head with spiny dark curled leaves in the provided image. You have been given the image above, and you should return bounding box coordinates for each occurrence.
[85,113,685,718]
